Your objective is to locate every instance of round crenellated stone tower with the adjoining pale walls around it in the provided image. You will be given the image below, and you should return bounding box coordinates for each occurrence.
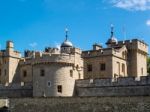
[19,40,83,97]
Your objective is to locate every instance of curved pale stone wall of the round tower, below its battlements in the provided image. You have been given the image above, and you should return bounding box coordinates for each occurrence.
[33,64,78,97]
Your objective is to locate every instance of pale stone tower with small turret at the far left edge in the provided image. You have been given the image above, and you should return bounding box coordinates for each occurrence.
[0,41,21,85]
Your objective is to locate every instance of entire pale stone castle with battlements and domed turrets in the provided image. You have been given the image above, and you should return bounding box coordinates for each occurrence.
[0,27,148,97]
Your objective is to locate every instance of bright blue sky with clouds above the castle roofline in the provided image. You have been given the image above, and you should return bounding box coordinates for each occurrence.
[0,0,150,52]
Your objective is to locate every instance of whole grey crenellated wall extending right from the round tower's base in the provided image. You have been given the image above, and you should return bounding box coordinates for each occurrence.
[76,76,150,96]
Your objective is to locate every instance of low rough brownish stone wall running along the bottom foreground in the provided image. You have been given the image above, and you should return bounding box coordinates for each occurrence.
[9,97,150,112]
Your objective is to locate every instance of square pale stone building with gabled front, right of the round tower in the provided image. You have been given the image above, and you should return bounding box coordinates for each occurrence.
[82,26,148,79]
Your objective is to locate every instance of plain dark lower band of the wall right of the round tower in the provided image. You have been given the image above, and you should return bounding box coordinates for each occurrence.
[77,85,150,97]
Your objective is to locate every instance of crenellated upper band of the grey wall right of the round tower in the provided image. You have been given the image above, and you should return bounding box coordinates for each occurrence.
[76,76,150,88]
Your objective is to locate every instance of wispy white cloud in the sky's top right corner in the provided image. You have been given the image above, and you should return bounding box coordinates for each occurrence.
[110,0,150,11]
